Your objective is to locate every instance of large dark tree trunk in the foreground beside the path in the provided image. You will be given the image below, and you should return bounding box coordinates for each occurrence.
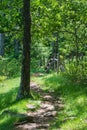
[17,0,31,100]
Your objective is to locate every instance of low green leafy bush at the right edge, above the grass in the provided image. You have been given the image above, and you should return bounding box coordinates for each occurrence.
[63,62,87,83]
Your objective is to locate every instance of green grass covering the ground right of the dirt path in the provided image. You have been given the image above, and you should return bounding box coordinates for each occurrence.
[34,74,87,130]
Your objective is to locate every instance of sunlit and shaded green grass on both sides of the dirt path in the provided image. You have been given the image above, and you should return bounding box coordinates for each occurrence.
[0,74,87,130]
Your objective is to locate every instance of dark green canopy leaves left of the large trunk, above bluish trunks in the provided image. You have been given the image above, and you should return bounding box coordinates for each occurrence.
[0,0,22,32]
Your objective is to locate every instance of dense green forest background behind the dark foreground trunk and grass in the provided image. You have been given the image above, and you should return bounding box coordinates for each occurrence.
[0,0,87,80]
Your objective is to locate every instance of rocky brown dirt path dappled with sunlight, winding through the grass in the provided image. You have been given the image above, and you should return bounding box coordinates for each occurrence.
[16,76,63,130]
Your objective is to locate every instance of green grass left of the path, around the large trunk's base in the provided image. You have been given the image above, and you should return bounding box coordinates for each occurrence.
[0,77,40,130]
